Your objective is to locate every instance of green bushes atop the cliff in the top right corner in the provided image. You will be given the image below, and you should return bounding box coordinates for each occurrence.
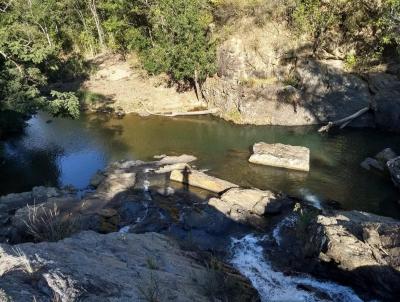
[292,0,400,64]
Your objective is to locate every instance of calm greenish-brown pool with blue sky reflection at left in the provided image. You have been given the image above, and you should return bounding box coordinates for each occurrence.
[0,114,400,217]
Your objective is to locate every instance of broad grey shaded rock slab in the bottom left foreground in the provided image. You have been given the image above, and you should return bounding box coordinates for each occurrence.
[0,232,257,302]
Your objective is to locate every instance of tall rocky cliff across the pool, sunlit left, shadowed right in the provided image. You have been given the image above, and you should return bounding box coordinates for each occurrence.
[203,20,400,131]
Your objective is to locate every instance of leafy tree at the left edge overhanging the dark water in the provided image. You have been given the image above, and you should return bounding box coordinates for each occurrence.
[0,0,83,134]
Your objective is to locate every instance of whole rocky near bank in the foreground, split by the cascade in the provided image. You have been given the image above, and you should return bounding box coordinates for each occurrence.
[0,155,400,301]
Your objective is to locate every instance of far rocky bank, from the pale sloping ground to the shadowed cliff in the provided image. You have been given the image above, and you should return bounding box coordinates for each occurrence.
[80,41,400,131]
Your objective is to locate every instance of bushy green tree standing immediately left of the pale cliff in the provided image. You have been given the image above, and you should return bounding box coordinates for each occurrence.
[142,0,215,81]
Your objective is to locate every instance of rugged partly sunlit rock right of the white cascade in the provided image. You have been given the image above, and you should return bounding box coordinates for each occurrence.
[306,211,400,301]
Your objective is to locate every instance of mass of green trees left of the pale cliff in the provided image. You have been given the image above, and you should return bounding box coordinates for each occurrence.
[0,0,215,136]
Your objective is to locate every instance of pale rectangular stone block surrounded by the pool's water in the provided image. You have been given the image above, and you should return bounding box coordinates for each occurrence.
[249,142,310,172]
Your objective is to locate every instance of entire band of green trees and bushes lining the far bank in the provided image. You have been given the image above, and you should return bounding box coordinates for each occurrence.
[0,0,400,136]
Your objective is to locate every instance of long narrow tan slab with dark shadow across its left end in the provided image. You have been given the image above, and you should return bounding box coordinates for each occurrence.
[170,167,238,193]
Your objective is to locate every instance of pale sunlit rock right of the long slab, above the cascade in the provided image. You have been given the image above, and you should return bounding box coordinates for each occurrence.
[208,188,290,227]
